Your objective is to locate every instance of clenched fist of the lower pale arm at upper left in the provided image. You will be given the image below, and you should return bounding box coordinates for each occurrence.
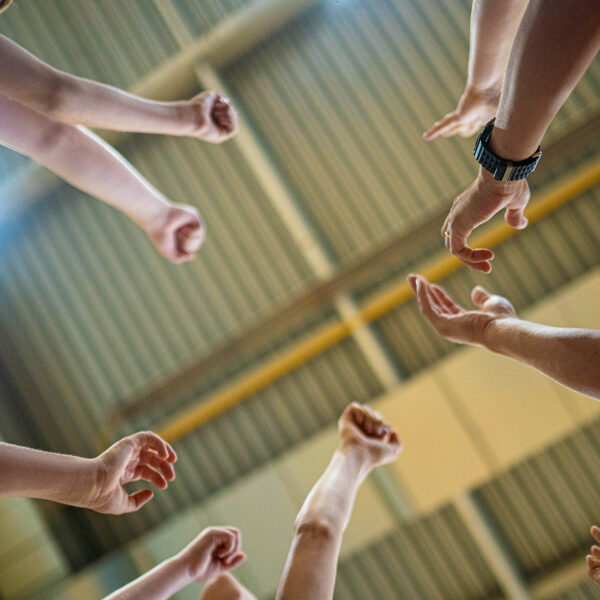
[145,204,206,265]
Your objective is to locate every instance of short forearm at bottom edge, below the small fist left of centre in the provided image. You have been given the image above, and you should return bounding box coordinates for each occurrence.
[105,557,192,600]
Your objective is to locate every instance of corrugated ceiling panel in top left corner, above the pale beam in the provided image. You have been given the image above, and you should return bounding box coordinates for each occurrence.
[0,0,178,88]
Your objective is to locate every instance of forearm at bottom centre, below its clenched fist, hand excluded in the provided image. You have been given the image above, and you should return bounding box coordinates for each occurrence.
[277,450,368,600]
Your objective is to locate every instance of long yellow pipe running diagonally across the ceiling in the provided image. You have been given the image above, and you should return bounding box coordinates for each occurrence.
[158,162,600,442]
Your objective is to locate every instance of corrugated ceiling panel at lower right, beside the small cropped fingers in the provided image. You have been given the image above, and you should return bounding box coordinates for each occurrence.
[476,421,600,577]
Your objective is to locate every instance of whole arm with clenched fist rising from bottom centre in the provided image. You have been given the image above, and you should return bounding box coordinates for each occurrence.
[277,404,400,600]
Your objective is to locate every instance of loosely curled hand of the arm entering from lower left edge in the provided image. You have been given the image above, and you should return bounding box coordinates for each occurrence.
[87,431,177,515]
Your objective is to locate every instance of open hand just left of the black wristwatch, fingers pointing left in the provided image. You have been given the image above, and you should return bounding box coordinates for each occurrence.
[423,85,502,142]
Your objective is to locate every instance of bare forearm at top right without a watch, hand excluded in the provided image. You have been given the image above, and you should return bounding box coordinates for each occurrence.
[467,0,527,92]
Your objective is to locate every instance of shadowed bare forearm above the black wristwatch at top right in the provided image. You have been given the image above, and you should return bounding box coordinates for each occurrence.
[491,0,600,160]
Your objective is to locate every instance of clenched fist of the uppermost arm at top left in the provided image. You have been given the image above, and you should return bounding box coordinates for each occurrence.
[188,92,240,144]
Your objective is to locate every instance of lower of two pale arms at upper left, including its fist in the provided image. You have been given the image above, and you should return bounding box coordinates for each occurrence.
[0,92,205,263]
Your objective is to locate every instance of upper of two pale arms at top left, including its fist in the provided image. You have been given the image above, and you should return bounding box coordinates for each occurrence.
[0,35,238,143]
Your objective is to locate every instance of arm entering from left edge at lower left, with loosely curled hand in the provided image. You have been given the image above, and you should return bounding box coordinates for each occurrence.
[0,431,177,515]
